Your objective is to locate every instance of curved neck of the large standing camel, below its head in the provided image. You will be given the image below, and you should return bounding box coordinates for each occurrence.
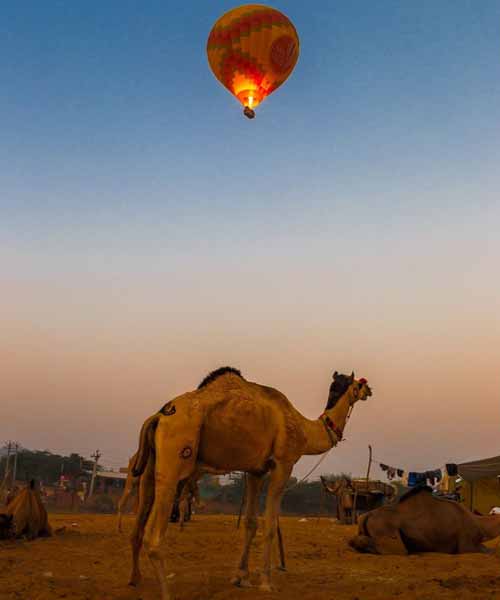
[301,394,350,454]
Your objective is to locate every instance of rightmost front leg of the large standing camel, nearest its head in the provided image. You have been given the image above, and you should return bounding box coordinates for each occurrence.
[260,463,293,591]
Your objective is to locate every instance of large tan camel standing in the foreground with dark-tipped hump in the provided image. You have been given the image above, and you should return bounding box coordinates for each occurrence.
[130,367,371,600]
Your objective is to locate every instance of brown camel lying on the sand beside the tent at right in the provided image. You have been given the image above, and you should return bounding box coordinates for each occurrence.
[349,487,500,554]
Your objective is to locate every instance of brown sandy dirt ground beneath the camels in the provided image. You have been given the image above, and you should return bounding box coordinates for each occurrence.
[0,514,500,600]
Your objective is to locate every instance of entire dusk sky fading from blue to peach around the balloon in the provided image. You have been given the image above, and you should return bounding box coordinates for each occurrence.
[0,0,500,475]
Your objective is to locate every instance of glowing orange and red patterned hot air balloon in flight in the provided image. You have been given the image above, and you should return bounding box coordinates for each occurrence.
[207,4,299,119]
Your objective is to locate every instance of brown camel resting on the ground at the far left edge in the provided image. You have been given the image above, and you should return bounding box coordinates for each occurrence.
[0,480,52,540]
